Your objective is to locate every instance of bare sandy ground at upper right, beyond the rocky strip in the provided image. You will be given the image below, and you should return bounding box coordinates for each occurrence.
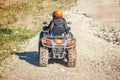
[76,0,120,30]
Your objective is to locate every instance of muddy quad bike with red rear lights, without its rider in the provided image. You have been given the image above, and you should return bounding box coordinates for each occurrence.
[39,21,77,67]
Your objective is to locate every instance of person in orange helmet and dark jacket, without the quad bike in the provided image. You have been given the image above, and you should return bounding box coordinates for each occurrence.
[48,10,70,34]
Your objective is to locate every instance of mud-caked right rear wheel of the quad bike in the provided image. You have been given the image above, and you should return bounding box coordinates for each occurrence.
[67,47,77,67]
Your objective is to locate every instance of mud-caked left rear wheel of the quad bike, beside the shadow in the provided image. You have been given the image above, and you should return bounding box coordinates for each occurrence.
[39,47,48,67]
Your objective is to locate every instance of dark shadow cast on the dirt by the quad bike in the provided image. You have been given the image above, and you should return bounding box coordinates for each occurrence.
[17,51,67,66]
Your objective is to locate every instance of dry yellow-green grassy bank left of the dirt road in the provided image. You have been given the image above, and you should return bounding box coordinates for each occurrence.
[0,0,76,62]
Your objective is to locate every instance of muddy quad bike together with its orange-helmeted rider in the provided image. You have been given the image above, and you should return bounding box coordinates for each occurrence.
[38,10,77,67]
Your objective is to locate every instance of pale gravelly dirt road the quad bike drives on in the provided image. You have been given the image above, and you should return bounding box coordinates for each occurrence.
[2,0,120,80]
